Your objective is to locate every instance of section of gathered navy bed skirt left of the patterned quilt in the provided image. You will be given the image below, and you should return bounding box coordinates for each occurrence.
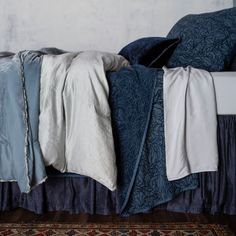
[0,177,119,215]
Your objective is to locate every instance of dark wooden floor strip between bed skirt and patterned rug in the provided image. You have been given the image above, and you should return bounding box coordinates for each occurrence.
[0,209,236,235]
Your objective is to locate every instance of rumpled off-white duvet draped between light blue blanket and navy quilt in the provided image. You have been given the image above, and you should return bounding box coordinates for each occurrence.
[39,51,129,190]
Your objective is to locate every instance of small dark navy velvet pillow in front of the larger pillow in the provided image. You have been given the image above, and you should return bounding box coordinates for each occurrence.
[119,37,179,68]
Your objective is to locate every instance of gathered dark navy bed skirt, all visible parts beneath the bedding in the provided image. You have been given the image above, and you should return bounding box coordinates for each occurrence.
[0,115,236,215]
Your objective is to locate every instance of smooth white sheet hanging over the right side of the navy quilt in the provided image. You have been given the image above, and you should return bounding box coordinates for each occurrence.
[163,67,218,180]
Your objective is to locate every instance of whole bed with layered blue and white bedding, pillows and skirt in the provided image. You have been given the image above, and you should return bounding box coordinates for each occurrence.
[0,8,236,216]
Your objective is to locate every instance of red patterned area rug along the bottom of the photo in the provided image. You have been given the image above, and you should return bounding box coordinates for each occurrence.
[0,223,234,236]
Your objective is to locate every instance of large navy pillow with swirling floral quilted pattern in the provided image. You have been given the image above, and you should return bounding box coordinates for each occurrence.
[167,8,236,71]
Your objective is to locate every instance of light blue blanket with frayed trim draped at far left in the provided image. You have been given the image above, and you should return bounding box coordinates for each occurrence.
[0,51,46,192]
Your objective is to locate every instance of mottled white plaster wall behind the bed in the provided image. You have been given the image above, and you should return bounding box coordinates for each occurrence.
[0,0,234,52]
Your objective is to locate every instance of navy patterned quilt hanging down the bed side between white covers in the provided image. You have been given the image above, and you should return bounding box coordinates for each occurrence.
[108,65,198,216]
